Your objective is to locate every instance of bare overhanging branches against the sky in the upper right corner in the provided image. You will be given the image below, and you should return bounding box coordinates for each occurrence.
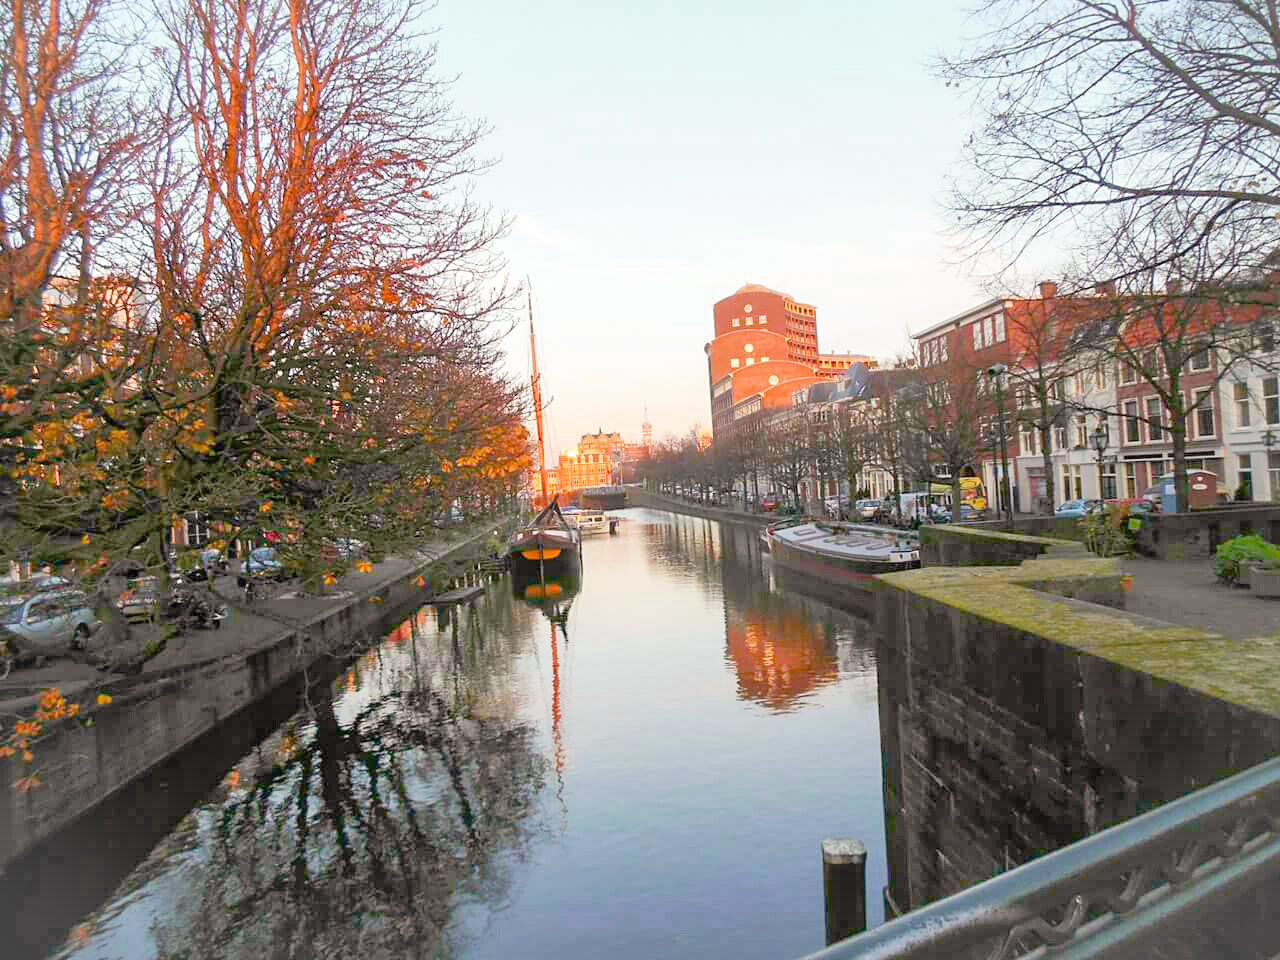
[941,0,1280,285]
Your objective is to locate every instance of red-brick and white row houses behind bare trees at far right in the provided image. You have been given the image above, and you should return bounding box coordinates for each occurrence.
[914,283,1280,509]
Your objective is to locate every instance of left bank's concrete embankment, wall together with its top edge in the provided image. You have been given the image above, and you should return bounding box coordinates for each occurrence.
[0,521,509,873]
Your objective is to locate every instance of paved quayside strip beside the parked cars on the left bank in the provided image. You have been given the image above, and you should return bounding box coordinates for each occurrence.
[0,524,504,726]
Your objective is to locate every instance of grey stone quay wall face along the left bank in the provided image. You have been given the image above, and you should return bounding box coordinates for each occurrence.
[0,527,509,873]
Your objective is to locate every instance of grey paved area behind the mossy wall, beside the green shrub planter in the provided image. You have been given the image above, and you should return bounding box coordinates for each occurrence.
[1121,557,1280,640]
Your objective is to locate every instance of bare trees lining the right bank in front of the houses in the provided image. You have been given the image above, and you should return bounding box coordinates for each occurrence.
[650,0,1280,522]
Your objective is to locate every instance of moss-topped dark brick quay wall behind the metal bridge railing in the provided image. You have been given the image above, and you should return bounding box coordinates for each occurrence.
[876,527,1280,936]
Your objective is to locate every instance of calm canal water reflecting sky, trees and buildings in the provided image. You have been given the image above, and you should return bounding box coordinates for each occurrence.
[29,509,886,960]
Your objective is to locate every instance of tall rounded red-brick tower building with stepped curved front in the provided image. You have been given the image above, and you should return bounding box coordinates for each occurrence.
[703,283,874,438]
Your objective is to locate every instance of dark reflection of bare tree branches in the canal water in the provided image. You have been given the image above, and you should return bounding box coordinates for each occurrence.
[156,601,545,960]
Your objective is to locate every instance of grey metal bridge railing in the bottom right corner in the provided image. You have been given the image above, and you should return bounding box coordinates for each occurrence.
[806,758,1280,960]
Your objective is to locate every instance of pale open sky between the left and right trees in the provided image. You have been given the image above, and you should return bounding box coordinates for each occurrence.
[431,0,1018,456]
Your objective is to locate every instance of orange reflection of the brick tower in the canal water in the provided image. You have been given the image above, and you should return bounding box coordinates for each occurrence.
[724,607,838,710]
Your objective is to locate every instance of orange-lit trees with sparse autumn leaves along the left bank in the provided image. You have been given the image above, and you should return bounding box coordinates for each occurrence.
[0,0,529,609]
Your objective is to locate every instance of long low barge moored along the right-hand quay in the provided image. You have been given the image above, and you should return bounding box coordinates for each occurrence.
[767,520,920,586]
